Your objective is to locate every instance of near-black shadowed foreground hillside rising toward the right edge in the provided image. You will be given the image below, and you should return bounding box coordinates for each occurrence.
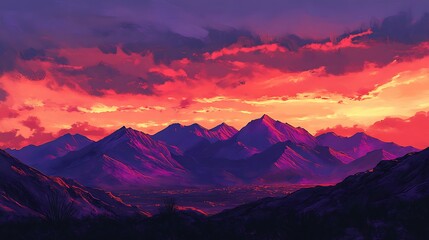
[212,149,429,239]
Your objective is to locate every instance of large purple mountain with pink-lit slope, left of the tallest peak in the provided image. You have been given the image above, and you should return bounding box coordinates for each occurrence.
[47,127,187,189]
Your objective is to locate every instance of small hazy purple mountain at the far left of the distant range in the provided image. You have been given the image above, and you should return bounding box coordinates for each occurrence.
[6,134,93,170]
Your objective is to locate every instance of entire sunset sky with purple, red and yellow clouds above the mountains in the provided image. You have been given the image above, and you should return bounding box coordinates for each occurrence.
[0,0,429,148]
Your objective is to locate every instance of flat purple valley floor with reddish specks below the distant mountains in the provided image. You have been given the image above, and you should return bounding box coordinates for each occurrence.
[114,184,315,215]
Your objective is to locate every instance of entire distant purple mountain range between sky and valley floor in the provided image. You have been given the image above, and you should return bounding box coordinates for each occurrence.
[7,115,417,189]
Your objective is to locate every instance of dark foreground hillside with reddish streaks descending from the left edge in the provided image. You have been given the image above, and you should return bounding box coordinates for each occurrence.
[0,150,139,221]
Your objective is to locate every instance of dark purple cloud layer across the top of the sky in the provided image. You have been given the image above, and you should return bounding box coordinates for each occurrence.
[0,0,429,95]
